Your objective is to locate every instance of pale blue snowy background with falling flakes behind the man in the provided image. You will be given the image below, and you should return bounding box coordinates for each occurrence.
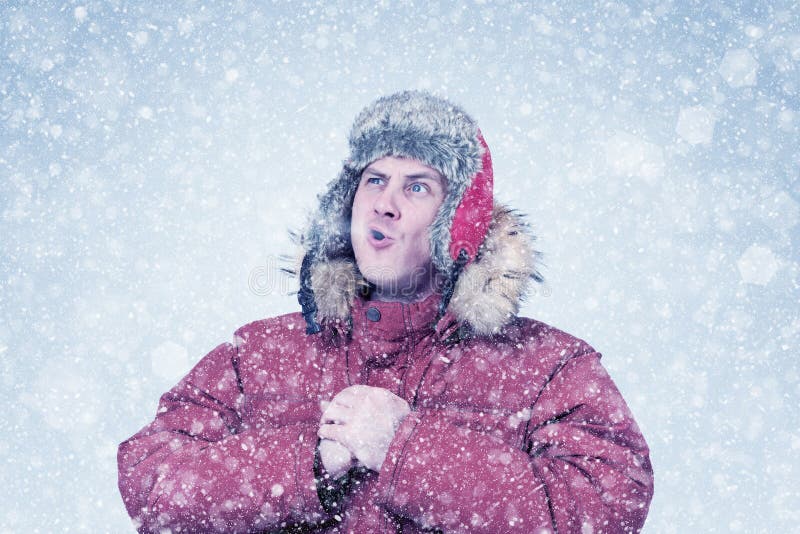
[0,0,800,533]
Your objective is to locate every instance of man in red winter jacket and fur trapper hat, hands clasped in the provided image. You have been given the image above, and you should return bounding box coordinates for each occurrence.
[118,92,653,533]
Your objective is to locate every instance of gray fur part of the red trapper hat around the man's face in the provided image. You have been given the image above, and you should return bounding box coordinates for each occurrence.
[308,91,491,274]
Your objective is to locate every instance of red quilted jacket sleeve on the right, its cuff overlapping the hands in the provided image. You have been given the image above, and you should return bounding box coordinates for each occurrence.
[372,352,653,533]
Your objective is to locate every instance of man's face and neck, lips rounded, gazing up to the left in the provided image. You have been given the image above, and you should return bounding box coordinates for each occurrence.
[350,156,446,301]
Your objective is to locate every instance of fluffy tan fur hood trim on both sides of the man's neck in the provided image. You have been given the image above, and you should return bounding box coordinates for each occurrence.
[311,202,543,335]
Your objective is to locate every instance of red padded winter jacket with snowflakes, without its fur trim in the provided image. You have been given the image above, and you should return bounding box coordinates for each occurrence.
[118,296,653,533]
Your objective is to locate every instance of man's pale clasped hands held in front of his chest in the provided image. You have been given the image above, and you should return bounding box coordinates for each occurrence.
[317,385,411,477]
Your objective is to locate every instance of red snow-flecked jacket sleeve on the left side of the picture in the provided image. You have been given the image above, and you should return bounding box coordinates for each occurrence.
[117,344,326,532]
